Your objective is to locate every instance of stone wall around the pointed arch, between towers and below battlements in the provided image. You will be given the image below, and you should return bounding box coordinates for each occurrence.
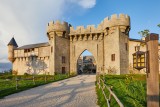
[70,34,104,73]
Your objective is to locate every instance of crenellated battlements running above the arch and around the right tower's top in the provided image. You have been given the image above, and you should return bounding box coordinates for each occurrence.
[70,14,130,35]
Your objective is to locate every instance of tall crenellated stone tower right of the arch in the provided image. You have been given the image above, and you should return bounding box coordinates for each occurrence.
[100,14,130,74]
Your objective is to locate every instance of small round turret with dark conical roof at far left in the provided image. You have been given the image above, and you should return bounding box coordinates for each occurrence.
[8,37,18,63]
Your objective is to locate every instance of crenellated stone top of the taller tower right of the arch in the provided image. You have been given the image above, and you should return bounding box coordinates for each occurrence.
[101,14,130,29]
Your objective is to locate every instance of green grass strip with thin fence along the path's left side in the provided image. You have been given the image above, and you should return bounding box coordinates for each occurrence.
[0,74,71,93]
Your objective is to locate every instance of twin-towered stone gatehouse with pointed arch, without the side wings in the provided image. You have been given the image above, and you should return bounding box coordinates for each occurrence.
[47,14,130,74]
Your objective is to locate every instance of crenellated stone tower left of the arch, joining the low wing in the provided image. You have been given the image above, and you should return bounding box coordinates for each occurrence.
[47,21,70,74]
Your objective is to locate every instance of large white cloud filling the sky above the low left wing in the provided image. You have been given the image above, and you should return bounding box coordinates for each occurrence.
[0,0,96,62]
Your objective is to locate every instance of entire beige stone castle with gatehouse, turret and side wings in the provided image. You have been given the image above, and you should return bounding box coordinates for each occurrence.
[8,14,160,75]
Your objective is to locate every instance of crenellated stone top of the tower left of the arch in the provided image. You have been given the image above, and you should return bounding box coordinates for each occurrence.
[47,20,70,33]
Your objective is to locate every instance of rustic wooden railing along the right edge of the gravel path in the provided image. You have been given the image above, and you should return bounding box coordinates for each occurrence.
[97,74,124,107]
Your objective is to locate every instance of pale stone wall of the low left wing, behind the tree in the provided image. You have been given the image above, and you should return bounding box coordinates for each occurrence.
[13,47,49,75]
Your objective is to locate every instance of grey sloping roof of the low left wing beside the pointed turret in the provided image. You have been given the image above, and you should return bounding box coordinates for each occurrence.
[17,42,49,49]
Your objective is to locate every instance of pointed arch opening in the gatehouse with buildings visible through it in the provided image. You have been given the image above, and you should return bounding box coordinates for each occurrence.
[77,50,96,74]
